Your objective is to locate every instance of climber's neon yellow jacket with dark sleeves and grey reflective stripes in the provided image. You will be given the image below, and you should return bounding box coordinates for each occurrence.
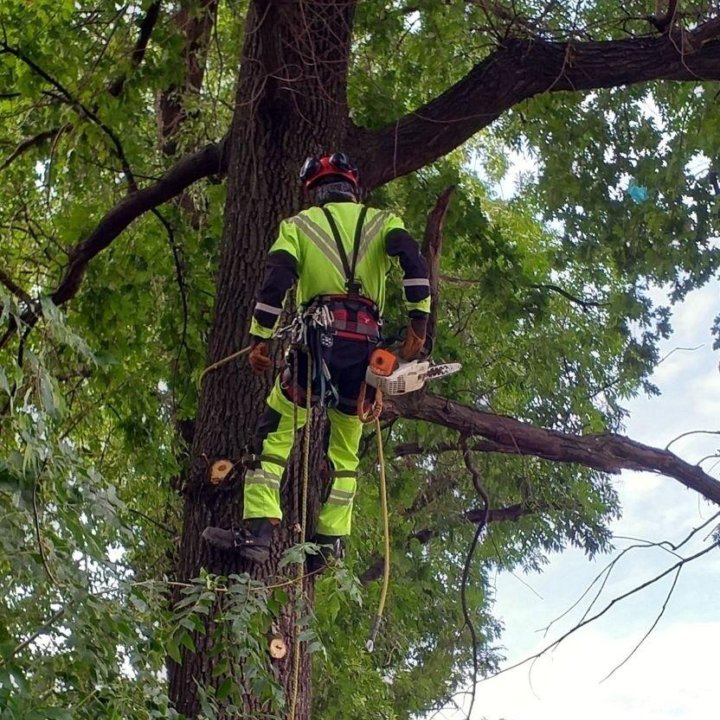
[250,202,430,338]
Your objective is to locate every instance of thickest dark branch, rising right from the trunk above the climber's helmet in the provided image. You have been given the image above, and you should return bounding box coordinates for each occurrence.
[358,23,720,189]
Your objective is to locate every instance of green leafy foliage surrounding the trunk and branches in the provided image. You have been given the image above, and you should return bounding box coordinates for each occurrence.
[0,0,720,720]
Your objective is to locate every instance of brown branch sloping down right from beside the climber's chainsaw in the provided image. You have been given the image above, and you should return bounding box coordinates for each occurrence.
[383,395,720,505]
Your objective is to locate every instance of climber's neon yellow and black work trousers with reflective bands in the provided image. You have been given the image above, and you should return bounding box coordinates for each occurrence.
[243,338,372,536]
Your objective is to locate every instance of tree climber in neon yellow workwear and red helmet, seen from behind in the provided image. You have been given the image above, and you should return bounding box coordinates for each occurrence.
[203,152,430,571]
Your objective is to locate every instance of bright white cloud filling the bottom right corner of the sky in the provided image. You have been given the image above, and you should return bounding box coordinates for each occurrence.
[474,621,720,720]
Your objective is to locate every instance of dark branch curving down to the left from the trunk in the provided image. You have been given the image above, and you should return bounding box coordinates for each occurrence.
[0,139,227,347]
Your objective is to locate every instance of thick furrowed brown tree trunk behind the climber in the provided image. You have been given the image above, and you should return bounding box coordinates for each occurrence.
[169,0,354,720]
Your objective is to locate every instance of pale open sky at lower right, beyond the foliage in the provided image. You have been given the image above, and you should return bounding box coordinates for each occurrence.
[438,283,720,720]
